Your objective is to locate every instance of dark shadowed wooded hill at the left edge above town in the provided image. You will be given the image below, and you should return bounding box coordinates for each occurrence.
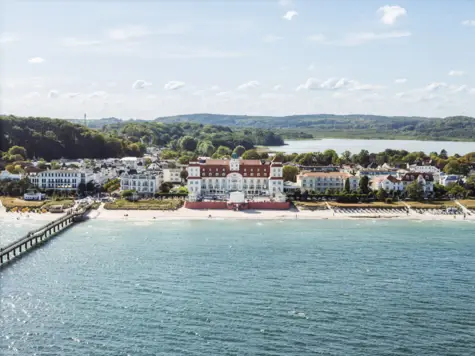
[0,116,145,160]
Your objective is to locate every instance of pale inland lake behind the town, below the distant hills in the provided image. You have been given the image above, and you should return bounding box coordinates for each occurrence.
[269,139,475,155]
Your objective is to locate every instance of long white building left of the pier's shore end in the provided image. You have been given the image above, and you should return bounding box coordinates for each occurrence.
[28,169,86,191]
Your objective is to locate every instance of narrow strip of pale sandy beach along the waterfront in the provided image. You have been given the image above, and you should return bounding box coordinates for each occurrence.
[85,206,475,221]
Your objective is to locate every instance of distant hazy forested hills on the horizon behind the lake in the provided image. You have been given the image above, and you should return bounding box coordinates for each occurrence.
[157,114,475,141]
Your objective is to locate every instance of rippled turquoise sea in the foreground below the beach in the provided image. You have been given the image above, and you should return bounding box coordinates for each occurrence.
[0,221,475,356]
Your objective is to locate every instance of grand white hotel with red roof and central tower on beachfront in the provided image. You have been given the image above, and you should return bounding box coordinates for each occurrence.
[187,155,284,199]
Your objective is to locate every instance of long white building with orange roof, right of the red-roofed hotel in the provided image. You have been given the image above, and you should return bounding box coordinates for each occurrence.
[297,172,360,193]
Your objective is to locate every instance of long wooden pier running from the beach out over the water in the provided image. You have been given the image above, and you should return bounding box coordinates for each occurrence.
[0,204,92,269]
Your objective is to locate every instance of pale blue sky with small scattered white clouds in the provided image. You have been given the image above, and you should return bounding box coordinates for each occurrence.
[0,0,475,119]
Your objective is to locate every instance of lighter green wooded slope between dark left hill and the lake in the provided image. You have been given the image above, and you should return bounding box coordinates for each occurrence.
[102,121,284,149]
